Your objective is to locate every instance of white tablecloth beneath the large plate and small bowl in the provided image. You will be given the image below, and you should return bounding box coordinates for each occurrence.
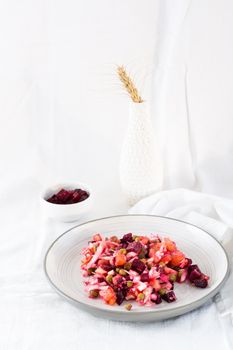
[0,179,230,350]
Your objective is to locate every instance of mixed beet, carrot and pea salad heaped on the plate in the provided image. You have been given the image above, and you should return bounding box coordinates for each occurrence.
[81,233,209,310]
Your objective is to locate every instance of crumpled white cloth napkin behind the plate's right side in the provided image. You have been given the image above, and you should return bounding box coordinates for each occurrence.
[129,189,233,346]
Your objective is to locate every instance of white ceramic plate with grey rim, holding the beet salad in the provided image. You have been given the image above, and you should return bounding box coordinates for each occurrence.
[44,215,229,321]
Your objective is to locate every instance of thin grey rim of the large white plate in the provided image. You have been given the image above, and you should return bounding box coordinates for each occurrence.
[43,214,230,320]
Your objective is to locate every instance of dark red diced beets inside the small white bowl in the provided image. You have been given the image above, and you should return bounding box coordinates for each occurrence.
[47,188,89,204]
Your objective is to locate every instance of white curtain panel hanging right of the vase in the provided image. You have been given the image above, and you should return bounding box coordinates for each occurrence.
[153,0,233,198]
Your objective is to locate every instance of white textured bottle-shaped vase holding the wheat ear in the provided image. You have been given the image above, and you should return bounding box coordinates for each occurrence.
[120,102,162,205]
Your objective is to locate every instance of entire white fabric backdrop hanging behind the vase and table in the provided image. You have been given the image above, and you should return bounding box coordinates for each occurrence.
[0,0,233,202]
